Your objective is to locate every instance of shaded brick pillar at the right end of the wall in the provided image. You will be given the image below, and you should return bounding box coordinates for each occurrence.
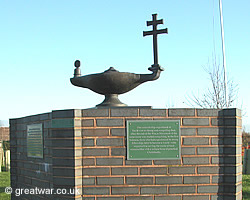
[220,109,242,200]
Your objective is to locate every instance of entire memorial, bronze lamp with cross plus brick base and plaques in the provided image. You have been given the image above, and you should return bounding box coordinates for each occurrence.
[10,14,242,200]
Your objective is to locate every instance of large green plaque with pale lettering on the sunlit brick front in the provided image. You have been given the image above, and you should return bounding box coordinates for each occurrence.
[127,120,181,160]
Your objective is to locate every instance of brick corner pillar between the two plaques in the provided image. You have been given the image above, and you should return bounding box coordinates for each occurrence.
[51,110,82,199]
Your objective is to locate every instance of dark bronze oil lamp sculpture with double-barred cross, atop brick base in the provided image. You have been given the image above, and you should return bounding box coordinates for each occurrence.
[70,14,168,107]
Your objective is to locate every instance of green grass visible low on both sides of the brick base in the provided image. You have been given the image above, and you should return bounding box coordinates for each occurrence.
[0,172,250,200]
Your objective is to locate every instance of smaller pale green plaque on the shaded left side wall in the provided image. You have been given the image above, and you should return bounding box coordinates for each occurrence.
[27,124,43,158]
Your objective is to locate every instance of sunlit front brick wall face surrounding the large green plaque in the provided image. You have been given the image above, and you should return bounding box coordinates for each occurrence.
[81,108,242,200]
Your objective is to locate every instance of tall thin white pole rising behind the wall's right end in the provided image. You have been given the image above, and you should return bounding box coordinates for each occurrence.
[219,0,228,108]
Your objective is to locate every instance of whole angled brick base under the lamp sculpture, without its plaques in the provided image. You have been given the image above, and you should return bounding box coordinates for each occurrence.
[10,107,242,200]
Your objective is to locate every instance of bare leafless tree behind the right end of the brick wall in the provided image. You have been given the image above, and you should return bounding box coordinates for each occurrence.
[186,58,238,109]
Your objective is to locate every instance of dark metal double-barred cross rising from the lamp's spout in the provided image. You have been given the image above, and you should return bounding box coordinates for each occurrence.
[143,14,168,66]
